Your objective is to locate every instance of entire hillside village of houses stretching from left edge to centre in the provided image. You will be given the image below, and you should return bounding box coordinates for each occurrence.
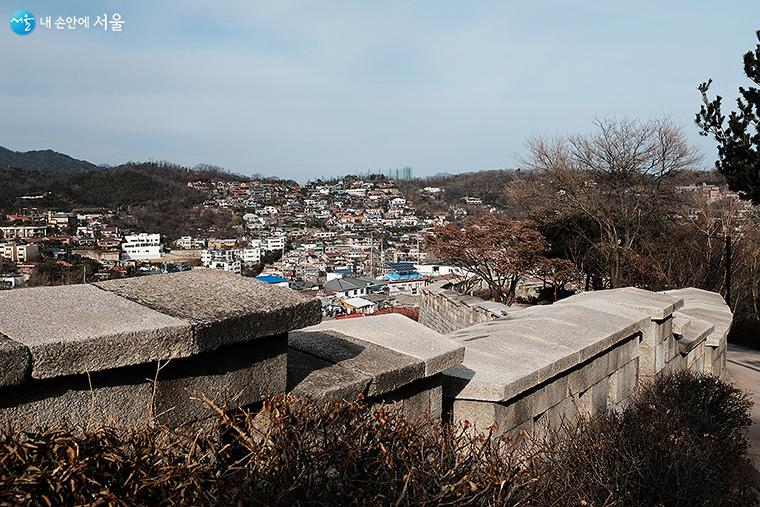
[0,175,481,317]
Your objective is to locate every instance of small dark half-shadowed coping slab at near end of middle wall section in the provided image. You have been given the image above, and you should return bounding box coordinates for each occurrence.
[288,348,372,401]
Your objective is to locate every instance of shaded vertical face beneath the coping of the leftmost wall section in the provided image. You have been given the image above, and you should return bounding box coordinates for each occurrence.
[0,336,287,428]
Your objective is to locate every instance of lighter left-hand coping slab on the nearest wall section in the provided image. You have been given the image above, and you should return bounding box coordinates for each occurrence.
[0,285,194,378]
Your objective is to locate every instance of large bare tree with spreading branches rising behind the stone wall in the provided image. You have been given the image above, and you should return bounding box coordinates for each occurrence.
[507,119,700,287]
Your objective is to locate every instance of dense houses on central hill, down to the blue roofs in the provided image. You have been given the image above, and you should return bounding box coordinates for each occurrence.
[174,177,470,317]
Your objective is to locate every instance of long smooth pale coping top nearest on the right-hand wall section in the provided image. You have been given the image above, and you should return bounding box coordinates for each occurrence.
[444,304,641,401]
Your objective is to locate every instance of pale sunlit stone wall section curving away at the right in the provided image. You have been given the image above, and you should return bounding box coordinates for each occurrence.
[420,288,732,436]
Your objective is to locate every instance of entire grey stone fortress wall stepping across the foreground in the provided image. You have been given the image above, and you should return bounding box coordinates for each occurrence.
[0,269,732,435]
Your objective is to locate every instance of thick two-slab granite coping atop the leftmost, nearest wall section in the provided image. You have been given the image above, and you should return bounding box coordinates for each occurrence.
[0,270,321,387]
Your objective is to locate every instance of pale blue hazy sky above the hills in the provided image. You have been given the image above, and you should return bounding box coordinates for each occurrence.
[0,0,760,180]
